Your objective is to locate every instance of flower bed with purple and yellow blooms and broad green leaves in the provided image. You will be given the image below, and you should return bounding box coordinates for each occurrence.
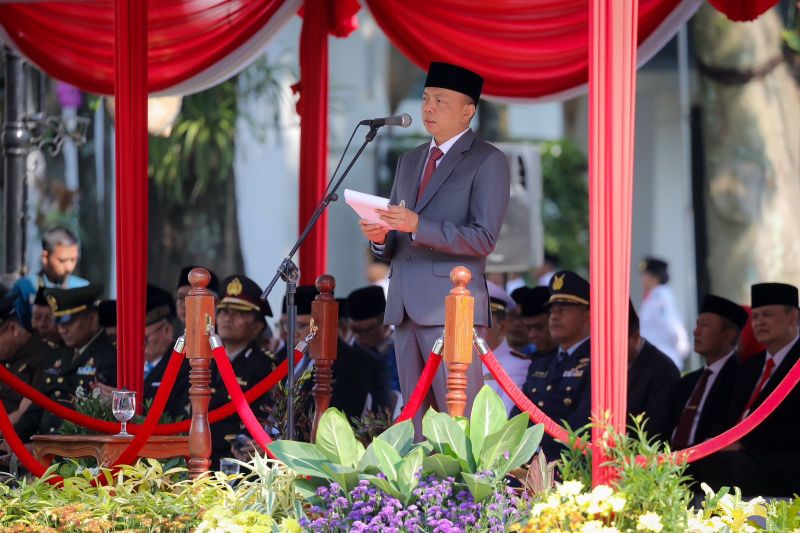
[0,388,800,533]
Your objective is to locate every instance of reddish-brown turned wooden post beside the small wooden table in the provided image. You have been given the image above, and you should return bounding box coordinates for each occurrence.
[186,268,215,478]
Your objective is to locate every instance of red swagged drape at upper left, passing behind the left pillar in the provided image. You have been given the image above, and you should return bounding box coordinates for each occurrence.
[0,0,286,94]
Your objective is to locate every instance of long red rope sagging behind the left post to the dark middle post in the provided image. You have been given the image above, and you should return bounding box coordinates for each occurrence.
[0,351,303,435]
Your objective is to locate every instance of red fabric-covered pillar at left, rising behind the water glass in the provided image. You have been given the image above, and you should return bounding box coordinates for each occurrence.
[114,0,148,405]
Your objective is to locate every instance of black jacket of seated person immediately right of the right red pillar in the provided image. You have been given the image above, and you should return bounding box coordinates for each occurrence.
[628,341,681,438]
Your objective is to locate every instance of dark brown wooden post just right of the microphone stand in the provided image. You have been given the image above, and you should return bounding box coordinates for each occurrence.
[308,274,339,442]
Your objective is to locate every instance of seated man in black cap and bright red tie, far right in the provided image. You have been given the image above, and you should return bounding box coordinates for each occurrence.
[689,283,800,497]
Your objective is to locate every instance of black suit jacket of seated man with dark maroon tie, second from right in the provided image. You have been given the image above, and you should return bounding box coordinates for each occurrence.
[666,354,741,445]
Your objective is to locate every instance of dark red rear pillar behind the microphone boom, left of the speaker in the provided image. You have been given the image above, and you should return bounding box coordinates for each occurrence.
[298,0,331,284]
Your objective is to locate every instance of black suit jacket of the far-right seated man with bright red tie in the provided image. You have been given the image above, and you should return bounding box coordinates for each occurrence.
[731,341,800,487]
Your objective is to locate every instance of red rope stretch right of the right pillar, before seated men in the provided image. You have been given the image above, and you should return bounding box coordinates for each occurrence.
[672,354,800,463]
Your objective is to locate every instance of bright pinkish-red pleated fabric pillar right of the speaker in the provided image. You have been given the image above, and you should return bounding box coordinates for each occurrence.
[589,0,638,485]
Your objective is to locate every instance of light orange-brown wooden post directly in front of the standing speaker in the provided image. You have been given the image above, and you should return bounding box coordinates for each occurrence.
[444,267,475,416]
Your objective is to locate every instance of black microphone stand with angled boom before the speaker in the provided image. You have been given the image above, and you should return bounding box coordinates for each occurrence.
[261,124,380,440]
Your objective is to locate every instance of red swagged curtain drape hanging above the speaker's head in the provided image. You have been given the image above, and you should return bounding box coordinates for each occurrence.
[366,0,681,98]
